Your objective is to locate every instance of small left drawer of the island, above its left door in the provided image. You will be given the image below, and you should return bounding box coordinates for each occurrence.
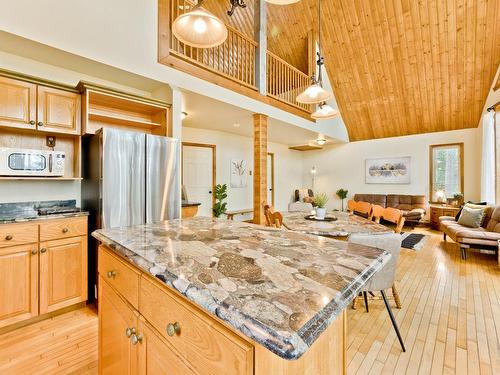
[97,246,140,309]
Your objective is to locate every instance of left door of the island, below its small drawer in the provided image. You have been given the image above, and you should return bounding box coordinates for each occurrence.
[98,277,139,375]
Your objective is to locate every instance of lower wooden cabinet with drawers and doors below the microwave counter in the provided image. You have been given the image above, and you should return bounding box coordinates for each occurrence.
[0,217,87,327]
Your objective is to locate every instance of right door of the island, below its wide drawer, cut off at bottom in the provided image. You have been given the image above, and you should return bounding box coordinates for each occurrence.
[138,318,196,375]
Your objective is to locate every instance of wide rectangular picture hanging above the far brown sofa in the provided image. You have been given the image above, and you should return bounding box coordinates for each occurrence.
[365,157,411,184]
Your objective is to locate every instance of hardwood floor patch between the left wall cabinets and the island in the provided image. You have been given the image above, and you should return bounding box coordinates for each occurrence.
[0,307,97,375]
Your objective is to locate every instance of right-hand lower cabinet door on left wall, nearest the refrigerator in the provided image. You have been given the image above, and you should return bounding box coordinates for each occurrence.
[40,236,87,314]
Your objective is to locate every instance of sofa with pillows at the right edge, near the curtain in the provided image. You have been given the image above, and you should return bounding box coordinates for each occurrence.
[439,206,500,259]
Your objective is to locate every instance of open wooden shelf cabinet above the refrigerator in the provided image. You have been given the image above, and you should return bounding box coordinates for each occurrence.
[78,82,170,136]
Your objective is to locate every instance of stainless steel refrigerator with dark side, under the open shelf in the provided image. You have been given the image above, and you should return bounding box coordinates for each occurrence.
[82,129,181,302]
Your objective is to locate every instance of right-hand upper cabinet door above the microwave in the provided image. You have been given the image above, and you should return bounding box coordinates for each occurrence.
[37,86,81,134]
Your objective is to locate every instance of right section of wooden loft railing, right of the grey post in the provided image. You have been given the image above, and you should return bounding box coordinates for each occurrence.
[267,51,311,111]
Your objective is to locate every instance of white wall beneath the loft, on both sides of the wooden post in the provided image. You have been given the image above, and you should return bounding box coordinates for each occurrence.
[182,127,302,219]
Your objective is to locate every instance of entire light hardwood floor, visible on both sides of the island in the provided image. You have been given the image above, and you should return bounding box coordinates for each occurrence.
[0,230,500,375]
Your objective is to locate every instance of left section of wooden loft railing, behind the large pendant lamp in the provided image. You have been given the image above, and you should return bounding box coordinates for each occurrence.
[170,0,258,89]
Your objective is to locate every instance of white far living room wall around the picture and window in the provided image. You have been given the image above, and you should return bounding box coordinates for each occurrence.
[303,129,481,209]
